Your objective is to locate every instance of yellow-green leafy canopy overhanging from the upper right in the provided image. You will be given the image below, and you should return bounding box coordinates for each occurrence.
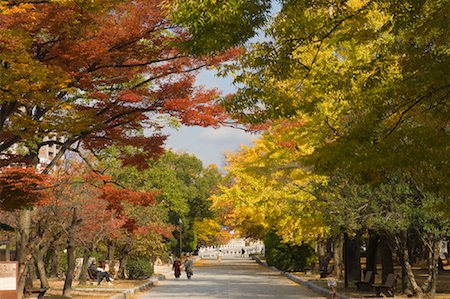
[224,0,450,194]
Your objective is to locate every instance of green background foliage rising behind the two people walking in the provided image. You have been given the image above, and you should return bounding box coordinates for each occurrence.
[102,148,221,256]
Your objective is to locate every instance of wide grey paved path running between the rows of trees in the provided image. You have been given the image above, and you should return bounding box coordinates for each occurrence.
[137,258,325,299]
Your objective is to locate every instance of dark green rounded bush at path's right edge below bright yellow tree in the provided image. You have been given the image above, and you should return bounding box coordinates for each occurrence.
[264,231,316,272]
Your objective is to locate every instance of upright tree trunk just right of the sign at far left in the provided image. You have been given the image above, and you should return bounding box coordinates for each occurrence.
[16,209,31,299]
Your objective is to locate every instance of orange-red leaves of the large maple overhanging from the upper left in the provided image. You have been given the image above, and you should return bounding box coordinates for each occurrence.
[0,0,239,170]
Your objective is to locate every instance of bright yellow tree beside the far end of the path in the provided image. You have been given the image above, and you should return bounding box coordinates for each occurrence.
[213,123,330,244]
